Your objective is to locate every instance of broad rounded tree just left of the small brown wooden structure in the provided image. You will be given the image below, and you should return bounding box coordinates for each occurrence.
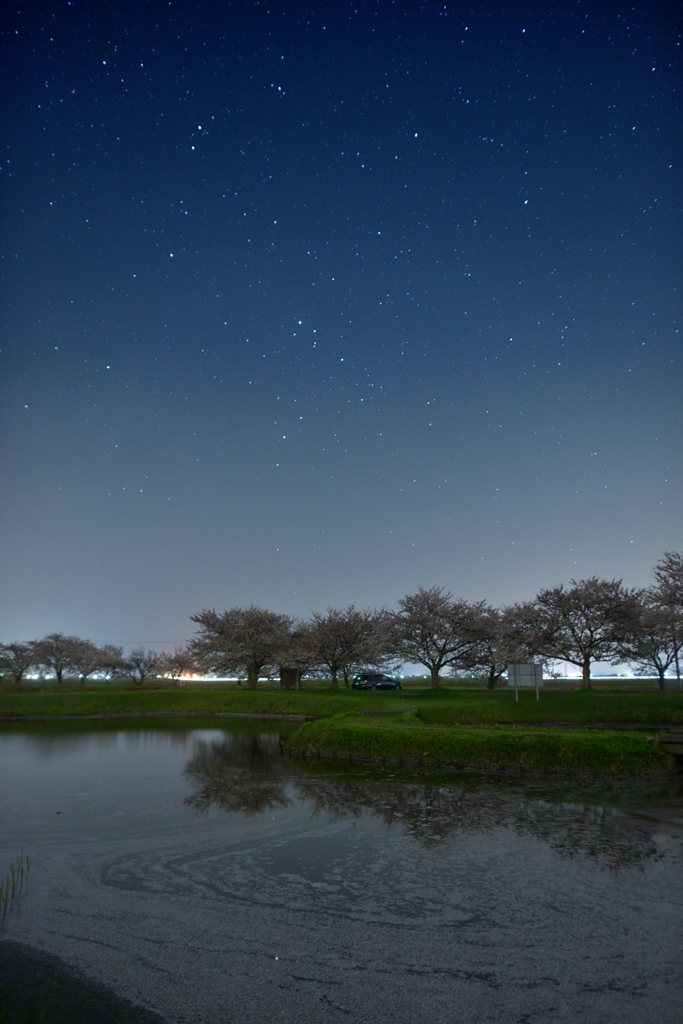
[189,605,293,689]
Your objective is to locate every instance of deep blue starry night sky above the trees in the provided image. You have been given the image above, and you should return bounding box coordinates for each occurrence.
[0,0,683,645]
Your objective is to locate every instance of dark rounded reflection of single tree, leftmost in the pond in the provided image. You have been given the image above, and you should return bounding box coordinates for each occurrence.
[183,735,292,814]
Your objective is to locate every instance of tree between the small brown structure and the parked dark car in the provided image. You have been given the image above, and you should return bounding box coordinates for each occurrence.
[306,604,380,689]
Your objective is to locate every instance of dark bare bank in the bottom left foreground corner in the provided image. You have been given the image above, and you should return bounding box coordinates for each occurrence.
[0,940,164,1024]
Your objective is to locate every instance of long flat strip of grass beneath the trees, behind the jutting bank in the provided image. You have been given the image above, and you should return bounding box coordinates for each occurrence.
[0,684,683,728]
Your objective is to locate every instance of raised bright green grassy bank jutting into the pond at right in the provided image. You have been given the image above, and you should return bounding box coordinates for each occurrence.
[289,715,670,779]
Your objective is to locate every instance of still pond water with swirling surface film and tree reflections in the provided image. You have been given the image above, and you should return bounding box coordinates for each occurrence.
[0,720,683,1024]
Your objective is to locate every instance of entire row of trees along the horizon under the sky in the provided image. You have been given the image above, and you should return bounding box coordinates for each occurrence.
[0,552,683,689]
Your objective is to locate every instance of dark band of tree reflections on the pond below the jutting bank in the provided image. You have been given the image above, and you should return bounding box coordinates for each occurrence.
[185,736,681,869]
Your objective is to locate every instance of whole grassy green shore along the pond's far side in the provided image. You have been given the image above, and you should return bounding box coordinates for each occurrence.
[0,690,683,780]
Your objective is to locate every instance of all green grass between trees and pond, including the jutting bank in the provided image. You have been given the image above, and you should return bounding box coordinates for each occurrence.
[0,684,683,778]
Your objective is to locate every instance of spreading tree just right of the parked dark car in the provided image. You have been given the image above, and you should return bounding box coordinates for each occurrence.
[390,587,486,687]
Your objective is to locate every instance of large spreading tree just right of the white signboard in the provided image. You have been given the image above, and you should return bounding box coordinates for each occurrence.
[524,577,642,688]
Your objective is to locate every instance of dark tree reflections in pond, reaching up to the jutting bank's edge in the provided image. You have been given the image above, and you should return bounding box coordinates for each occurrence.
[184,736,683,868]
